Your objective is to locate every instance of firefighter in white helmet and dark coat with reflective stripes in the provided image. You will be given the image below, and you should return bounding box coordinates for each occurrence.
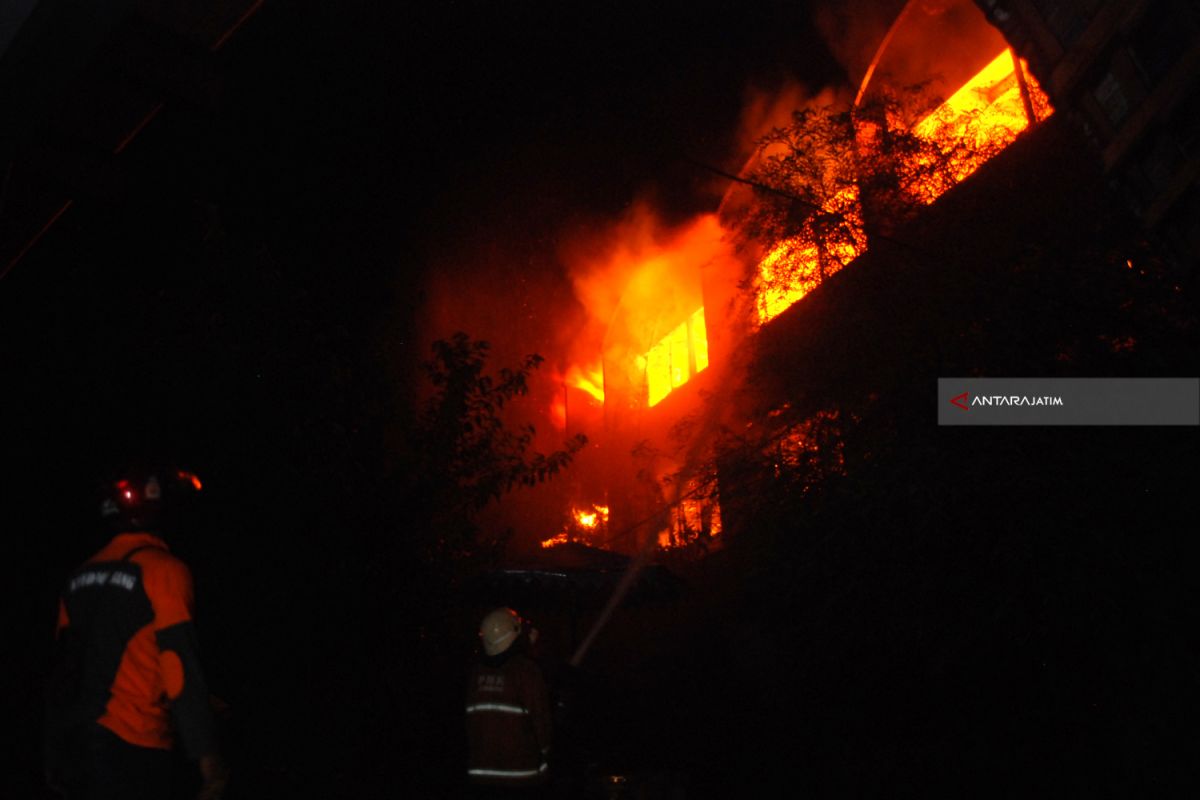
[467,608,551,796]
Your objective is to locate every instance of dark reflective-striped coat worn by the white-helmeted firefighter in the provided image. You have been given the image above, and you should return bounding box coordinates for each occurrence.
[467,651,551,786]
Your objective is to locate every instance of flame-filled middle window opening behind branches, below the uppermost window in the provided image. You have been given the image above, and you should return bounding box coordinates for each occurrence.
[756,187,866,325]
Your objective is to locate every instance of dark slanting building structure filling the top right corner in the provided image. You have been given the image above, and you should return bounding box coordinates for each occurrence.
[976,0,1200,263]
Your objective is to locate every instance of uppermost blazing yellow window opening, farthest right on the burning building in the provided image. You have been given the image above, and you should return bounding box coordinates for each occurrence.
[913,49,1054,203]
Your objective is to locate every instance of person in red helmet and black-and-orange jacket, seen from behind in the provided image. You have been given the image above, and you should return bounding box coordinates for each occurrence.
[46,470,228,800]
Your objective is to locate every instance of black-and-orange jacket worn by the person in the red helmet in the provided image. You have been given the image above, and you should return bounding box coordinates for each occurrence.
[56,533,216,758]
